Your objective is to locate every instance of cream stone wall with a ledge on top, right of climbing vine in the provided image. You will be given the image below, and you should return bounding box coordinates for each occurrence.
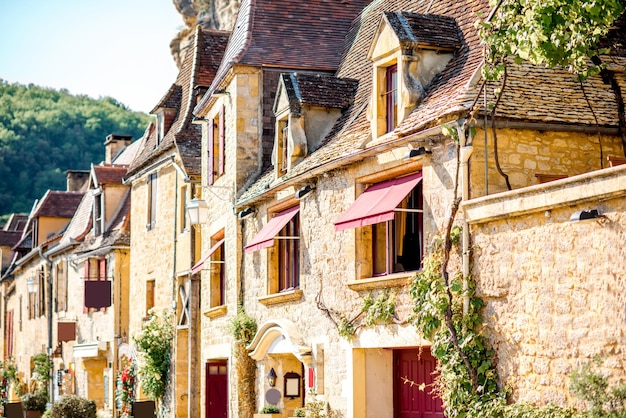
[466,166,626,405]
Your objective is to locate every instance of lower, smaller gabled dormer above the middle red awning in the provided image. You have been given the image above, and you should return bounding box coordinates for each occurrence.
[272,73,358,178]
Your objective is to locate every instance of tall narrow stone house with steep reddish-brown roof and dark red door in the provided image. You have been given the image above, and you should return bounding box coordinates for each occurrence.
[193,1,367,417]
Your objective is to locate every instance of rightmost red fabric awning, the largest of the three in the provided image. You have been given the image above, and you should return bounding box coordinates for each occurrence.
[335,172,422,231]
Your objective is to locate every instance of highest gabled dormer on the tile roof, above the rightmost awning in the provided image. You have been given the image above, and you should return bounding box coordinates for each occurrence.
[368,12,461,139]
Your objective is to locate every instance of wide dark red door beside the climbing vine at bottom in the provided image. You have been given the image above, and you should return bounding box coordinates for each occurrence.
[393,347,443,418]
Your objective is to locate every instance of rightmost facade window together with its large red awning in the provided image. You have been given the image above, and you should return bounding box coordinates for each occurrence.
[335,172,423,277]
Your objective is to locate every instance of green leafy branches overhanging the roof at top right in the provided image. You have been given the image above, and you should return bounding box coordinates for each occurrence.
[478,0,625,78]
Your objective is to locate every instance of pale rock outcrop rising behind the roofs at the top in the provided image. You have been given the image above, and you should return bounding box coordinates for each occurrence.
[170,0,240,68]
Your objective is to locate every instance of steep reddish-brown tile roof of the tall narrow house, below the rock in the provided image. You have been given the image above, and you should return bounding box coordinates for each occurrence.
[194,0,369,115]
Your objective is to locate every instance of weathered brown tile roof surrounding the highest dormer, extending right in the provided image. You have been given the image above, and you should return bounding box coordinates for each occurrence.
[238,0,626,203]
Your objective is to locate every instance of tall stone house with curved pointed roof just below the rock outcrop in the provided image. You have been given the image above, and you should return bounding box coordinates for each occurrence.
[124,27,228,417]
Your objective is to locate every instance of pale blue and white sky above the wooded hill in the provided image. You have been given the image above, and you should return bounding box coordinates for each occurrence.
[0,0,184,113]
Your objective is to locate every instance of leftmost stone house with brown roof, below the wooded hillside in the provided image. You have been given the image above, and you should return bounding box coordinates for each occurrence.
[2,183,87,401]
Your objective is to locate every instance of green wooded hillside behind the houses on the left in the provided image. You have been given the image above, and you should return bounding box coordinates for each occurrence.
[0,79,150,219]
